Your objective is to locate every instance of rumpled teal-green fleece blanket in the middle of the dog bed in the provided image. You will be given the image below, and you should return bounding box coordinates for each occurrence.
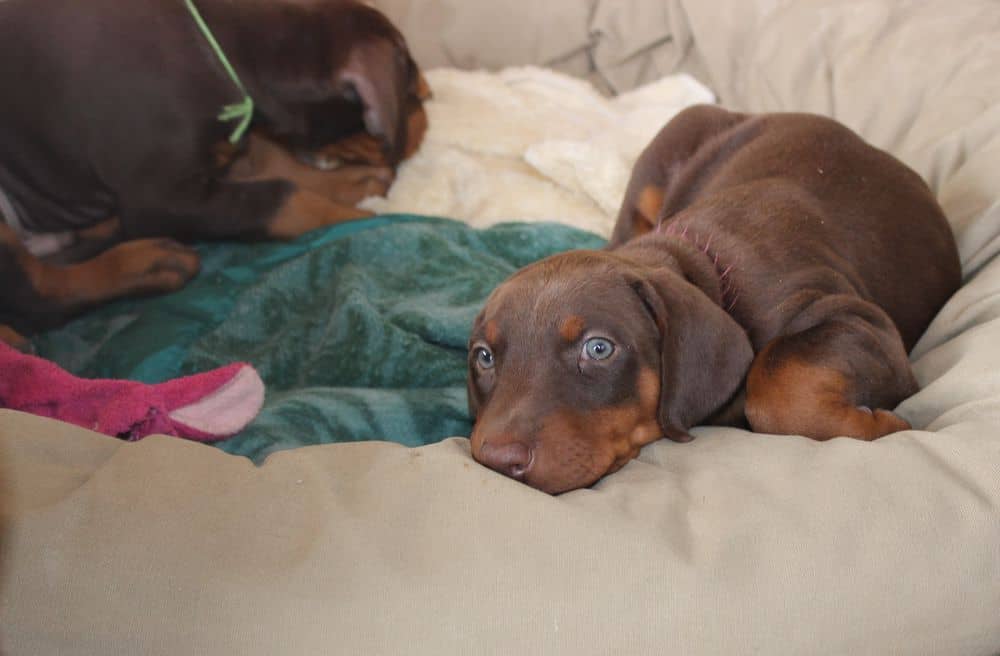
[35,216,603,461]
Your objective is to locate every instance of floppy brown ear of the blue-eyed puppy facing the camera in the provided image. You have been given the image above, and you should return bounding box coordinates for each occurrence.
[630,270,753,442]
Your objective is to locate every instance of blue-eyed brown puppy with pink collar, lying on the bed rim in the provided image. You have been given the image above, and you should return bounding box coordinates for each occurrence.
[468,106,960,493]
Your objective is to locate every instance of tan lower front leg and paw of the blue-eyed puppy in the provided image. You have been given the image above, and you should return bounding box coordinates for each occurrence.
[745,344,910,440]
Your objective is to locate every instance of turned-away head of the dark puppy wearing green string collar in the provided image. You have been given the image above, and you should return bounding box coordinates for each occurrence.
[262,0,430,165]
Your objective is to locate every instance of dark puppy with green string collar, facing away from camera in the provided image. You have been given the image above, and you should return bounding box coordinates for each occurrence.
[0,0,429,343]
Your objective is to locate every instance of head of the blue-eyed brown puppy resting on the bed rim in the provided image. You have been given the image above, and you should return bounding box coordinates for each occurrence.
[468,251,752,494]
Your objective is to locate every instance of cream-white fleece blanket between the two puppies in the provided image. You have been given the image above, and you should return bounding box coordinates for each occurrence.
[363,67,714,237]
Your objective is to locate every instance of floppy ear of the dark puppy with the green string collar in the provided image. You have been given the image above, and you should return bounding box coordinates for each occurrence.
[336,39,411,160]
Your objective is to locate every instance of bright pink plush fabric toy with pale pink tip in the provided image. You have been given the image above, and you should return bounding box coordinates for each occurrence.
[0,341,264,442]
